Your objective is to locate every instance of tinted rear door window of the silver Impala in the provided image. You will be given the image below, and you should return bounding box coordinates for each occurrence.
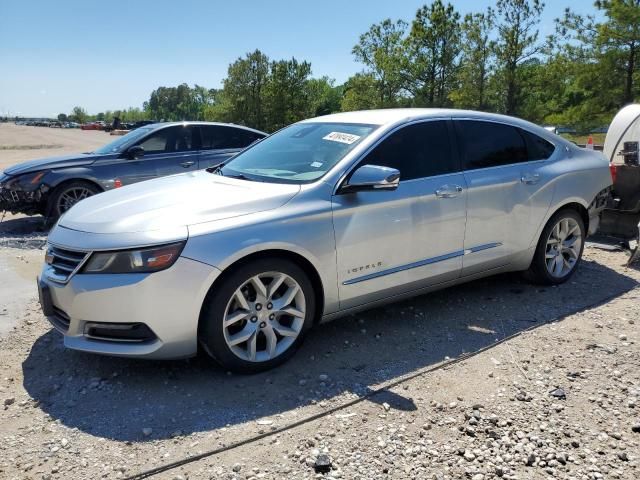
[457,120,527,170]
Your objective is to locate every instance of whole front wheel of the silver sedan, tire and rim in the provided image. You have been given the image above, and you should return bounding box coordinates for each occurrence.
[199,259,315,373]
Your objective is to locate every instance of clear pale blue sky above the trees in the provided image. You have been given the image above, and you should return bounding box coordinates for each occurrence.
[0,0,593,116]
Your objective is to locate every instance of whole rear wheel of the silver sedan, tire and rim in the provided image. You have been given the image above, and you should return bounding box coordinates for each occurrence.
[527,210,586,285]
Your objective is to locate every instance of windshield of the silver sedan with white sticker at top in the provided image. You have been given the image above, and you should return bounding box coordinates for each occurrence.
[219,123,376,183]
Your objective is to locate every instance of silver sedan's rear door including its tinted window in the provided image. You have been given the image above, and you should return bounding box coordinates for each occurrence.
[454,120,553,275]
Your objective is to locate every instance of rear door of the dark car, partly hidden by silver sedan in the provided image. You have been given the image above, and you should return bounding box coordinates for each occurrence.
[198,125,265,169]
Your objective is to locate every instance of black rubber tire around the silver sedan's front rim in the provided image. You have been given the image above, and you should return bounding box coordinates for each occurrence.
[198,258,316,374]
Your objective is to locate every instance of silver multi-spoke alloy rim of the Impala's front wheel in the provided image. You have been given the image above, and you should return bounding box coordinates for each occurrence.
[222,272,306,362]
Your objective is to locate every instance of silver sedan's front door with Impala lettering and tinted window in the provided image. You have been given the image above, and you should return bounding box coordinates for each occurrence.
[332,120,466,309]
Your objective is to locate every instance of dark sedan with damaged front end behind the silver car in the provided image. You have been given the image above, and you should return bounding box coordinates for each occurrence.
[0,122,267,220]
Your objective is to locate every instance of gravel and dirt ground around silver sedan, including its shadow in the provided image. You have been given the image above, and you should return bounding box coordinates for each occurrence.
[0,127,640,480]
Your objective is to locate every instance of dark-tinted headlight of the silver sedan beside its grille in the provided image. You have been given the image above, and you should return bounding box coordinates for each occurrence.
[82,242,185,273]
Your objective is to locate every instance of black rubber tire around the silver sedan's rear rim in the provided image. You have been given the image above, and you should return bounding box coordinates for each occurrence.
[525,209,586,285]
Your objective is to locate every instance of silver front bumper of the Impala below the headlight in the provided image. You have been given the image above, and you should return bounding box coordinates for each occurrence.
[38,257,220,359]
